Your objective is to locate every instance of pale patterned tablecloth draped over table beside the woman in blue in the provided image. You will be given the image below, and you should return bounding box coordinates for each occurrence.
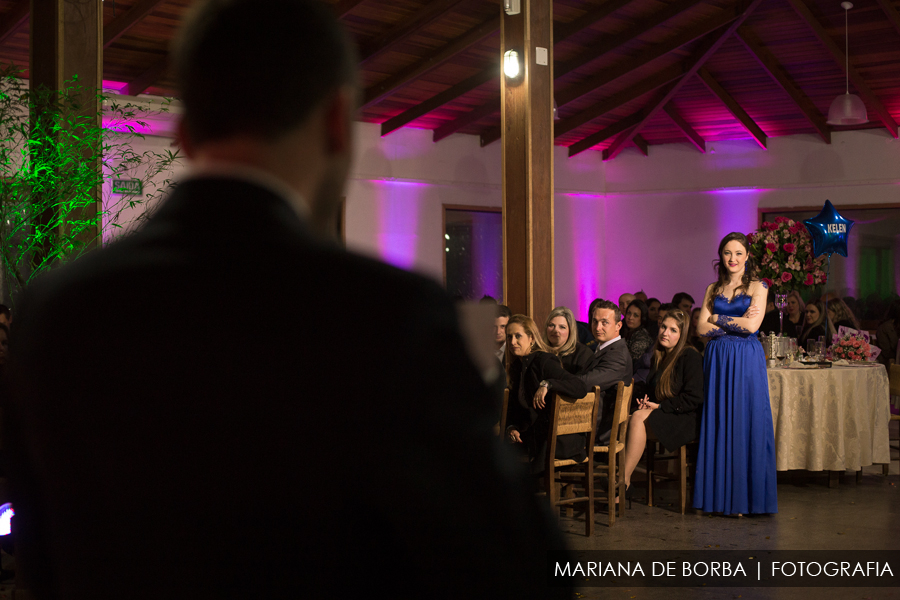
[768,363,890,471]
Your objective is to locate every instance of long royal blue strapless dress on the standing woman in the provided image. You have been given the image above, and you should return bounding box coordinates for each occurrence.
[694,284,778,514]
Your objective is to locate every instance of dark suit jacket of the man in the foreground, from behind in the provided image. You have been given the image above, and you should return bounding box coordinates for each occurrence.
[4,178,569,600]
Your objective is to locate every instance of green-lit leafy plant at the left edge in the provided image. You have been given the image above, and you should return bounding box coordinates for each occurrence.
[0,66,181,298]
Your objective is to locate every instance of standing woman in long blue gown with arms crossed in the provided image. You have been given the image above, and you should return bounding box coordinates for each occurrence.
[694,233,778,515]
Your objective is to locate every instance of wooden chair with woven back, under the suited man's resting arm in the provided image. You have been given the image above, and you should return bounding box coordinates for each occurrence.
[544,388,600,536]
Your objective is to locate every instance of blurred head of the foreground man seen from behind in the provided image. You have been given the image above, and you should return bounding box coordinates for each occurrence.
[171,0,357,232]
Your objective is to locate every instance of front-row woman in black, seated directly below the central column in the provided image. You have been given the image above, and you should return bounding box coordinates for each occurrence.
[506,315,590,474]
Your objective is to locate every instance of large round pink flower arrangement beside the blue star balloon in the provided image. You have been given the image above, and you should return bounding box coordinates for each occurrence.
[747,217,827,293]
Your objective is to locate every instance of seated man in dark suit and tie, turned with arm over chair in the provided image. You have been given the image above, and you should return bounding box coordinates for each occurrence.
[535,300,632,443]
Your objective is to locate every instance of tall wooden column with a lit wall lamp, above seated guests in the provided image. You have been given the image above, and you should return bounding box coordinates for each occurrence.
[500,0,554,324]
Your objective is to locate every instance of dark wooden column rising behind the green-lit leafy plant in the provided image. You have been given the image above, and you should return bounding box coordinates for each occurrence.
[29,0,103,248]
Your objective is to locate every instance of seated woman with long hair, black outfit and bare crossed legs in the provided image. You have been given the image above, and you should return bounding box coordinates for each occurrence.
[623,309,704,499]
